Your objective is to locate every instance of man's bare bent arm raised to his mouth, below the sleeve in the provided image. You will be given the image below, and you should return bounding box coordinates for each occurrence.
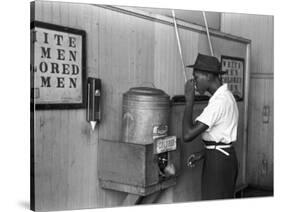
[182,80,208,142]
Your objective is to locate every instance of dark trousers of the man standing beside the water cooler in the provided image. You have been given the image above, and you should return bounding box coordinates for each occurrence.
[202,142,238,200]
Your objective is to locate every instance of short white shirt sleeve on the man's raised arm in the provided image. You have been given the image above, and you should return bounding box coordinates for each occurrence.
[195,101,224,128]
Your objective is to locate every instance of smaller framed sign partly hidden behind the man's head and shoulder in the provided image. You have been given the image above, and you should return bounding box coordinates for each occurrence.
[221,55,244,101]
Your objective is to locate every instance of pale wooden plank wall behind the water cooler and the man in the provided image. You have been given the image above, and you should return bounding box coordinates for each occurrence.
[34,1,249,210]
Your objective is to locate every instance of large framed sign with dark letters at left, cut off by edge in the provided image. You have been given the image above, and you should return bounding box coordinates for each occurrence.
[30,21,86,109]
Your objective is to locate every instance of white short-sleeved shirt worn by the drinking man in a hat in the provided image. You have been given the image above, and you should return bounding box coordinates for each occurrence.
[195,84,239,144]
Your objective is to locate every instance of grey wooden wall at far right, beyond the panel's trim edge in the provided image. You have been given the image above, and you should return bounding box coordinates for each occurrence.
[221,14,274,189]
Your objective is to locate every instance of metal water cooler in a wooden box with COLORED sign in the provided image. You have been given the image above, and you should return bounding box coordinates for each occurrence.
[99,87,180,196]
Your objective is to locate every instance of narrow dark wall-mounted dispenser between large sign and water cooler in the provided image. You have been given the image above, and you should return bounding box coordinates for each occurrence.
[86,77,101,124]
